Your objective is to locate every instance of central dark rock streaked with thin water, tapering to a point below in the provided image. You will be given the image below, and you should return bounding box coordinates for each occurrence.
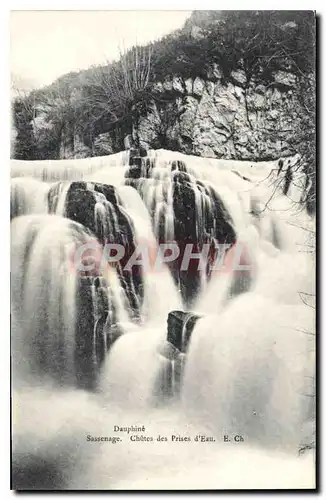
[125,158,237,307]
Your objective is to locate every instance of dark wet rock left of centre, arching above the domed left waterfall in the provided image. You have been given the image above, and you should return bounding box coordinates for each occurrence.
[48,182,143,321]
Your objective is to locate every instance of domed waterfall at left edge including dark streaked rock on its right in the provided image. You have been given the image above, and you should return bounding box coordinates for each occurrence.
[11,211,136,388]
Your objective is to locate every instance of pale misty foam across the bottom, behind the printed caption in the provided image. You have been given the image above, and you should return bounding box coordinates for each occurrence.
[13,388,314,490]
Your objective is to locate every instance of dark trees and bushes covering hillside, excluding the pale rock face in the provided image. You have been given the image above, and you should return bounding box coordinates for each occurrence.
[13,11,316,205]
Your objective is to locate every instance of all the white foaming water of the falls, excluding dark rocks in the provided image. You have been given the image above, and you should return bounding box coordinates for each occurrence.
[12,150,315,490]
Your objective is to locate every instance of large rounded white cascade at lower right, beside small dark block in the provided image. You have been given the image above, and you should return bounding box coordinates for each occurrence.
[183,292,314,450]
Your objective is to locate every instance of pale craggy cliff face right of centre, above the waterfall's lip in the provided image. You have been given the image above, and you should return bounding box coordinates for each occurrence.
[134,67,296,160]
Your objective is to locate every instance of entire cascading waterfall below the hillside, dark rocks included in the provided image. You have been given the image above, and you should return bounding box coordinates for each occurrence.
[11,150,315,489]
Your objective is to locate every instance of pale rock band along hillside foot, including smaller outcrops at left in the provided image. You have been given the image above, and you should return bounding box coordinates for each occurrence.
[12,64,297,161]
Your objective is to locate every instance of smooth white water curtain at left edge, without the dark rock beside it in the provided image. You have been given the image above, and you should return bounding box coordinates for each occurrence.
[11,215,88,386]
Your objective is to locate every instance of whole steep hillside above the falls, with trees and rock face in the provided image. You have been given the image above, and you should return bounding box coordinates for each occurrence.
[14,11,315,163]
